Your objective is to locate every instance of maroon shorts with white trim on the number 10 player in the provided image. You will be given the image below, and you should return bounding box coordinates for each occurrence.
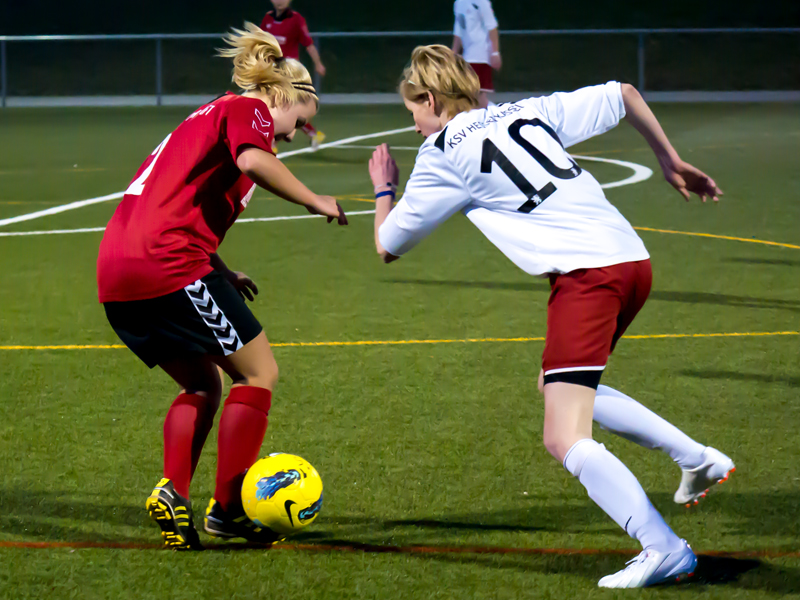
[542,260,653,388]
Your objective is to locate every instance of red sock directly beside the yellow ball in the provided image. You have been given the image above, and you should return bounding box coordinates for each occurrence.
[214,385,272,510]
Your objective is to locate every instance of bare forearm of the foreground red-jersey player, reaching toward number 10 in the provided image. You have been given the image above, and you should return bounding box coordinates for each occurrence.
[236,148,347,225]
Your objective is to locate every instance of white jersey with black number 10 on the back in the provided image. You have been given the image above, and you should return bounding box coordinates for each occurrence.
[379,81,649,275]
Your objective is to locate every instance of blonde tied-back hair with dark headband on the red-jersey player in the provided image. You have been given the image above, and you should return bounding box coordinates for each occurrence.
[217,23,319,106]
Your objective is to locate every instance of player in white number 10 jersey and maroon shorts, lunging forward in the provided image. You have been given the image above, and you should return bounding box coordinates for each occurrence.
[370,46,734,587]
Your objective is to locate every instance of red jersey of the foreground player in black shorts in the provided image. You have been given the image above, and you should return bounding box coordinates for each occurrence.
[97,92,274,302]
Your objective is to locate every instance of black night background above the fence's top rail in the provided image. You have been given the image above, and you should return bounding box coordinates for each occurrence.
[0,0,800,35]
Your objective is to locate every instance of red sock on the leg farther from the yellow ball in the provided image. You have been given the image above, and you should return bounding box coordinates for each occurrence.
[164,394,217,498]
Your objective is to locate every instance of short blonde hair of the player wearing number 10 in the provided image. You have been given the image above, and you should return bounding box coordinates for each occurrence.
[400,44,481,117]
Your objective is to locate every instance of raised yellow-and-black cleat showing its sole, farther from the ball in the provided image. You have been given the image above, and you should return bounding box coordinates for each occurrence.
[145,479,203,550]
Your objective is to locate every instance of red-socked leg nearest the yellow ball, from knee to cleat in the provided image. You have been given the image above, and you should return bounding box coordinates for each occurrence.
[205,331,280,544]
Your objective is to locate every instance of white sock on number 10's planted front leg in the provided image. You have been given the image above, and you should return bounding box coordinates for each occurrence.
[564,439,682,552]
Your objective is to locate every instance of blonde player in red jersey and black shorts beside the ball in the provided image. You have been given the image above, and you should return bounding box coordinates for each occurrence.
[97,23,347,549]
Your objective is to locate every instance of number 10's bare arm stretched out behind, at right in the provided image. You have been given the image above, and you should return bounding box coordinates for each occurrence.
[621,83,722,202]
